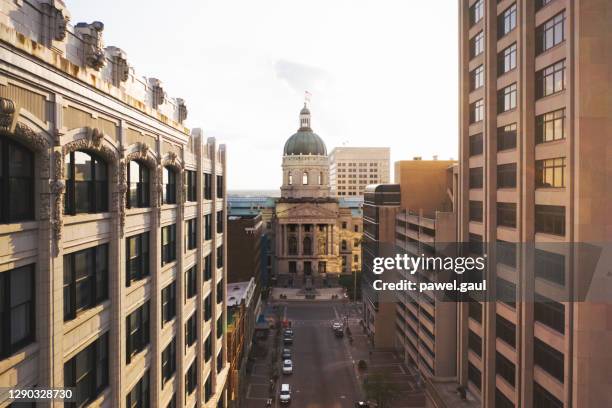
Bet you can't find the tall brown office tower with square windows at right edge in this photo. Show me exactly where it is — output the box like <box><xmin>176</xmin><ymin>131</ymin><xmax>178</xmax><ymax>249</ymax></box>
<box><xmin>428</xmin><ymin>0</ymin><xmax>612</xmax><ymax>408</ymax></box>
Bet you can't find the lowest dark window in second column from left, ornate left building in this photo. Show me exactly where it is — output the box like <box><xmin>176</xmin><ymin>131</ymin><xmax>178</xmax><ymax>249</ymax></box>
<box><xmin>64</xmin><ymin>332</ymin><xmax>109</xmax><ymax>407</ymax></box>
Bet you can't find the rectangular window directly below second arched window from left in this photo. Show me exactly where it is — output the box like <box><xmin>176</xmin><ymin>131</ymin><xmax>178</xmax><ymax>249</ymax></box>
<box><xmin>64</xmin><ymin>244</ymin><xmax>108</xmax><ymax>321</ymax></box>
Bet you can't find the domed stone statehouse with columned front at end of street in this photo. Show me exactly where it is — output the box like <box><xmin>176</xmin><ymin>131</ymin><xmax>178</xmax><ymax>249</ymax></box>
<box><xmin>271</xmin><ymin>104</ymin><xmax>362</xmax><ymax>285</ymax></box>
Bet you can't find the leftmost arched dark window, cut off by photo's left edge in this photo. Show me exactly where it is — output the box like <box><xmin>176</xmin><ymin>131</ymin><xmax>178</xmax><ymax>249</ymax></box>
<box><xmin>0</xmin><ymin>136</ymin><xmax>34</xmax><ymax>224</ymax></box>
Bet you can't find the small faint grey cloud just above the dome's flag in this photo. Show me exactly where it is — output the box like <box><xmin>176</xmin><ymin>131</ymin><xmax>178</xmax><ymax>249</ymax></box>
<box><xmin>274</xmin><ymin>59</ymin><xmax>333</xmax><ymax>94</ymax></box>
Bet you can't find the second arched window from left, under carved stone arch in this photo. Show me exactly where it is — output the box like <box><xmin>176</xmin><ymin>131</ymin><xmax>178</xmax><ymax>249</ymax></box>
<box><xmin>64</xmin><ymin>151</ymin><xmax>108</xmax><ymax>215</ymax></box>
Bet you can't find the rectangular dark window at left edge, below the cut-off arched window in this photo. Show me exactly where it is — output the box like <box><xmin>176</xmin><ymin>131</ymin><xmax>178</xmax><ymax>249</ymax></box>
<box><xmin>0</xmin><ymin>264</ymin><xmax>35</xmax><ymax>358</ymax></box>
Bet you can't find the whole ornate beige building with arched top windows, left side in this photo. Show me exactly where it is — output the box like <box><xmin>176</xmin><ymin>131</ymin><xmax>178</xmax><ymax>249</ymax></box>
<box><xmin>0</xmin><ymin>0</ymin><xmax>228</xmax><ymax>407</ymax></box>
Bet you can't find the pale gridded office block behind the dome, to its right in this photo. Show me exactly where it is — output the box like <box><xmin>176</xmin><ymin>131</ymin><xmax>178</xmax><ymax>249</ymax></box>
<box><xmin>329</xmin><ymin>147</ymin><xmax>390</xmax><ymax>197</ymax></box>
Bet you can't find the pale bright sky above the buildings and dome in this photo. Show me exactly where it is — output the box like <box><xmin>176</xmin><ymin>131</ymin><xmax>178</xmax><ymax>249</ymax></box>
<box><xmin>66</xmin><ymin>0</ymin><xmax>458</xmax><ymax>190</ymax></box>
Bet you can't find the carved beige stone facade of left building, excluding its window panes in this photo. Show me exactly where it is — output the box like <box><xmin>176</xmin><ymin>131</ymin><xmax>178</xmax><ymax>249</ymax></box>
<box><xmin>0</xmin><ymin>0</ymin><xmax>228</xmax><ymax>407</ymax></box>
